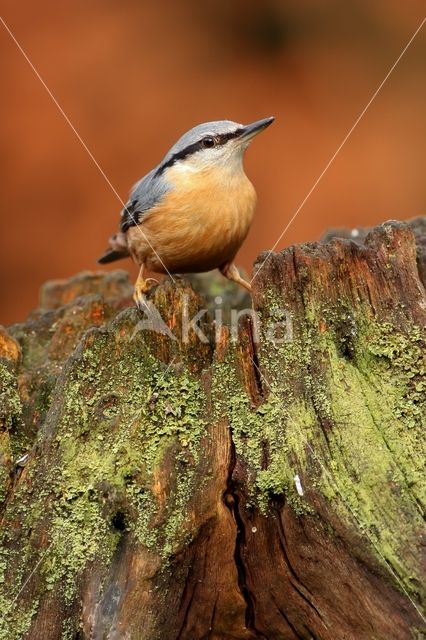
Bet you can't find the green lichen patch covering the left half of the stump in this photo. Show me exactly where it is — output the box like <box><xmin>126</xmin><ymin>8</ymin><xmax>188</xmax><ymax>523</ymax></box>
<box><xmin>0</xmin><ymin>314</ymin><xmax>206</xmax><ymax>640</ymax></box>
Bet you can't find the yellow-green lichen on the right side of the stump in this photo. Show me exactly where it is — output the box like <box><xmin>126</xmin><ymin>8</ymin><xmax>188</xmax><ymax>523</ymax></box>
<box><xmin>260</xmin><ymin>290</ymin><xmax>426</xmax><ymax>595</ymax></box>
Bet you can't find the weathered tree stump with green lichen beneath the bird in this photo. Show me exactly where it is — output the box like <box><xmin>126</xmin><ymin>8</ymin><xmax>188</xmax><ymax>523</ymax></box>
<box><xmin>0</xmin><ymin>219</ymin><xmax>426</xmax><ymax>640</ymax></box>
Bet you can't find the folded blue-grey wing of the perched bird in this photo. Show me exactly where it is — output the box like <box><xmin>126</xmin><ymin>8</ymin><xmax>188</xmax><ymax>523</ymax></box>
<box><xmin>120</xmin><ymin>168</ymin><xmax>171</xmax><ymax>232</ymax></box>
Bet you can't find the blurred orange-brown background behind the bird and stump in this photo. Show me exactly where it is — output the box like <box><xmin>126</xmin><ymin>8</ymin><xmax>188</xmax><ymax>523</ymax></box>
<box><xmin>0</xmin><ymin>0</ymin><xmax>426</xmax><ymax>324</ymax></box>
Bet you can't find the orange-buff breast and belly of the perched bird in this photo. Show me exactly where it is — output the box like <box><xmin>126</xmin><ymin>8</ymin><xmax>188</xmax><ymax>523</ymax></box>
<box><xmin>128</xmin><ymin>168</ymin><xmax>256</xmax><ymax>273</ymax></box>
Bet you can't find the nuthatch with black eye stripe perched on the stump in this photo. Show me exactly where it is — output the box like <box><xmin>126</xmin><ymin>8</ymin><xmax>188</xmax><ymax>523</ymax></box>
<box><xmin>98</xmin><ymin>117</ymin><xmax>275</xmax><ymax>308</ymax></box>
